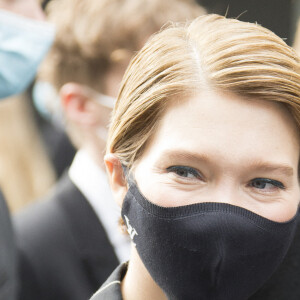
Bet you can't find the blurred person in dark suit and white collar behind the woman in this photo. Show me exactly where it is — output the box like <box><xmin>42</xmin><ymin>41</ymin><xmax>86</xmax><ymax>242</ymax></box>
<box><xmin>14</xmin><ymin>0</ymin><xmax>205</xmax><ymax>300</ymax></box>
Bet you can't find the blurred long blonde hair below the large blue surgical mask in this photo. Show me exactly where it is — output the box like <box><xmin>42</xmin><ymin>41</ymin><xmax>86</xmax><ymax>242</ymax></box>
<box><xmin>0</xmin><ymin>93</ymin><xmax>56</xmax><ymax>213</ymax></box>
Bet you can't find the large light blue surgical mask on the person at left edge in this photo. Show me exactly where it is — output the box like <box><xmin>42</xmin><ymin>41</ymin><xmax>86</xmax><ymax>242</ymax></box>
<box><xmin>0</xmin><ymin>10</ymin><xmax>55</xmax><ymax>99</ymax></box>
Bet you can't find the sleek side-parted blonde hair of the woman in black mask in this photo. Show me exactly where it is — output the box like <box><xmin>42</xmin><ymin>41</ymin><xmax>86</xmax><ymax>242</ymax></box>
<box><xmin>107</xmin><ymin>15</ymin><xmax>300</xmax><ymax>168</ymax></box>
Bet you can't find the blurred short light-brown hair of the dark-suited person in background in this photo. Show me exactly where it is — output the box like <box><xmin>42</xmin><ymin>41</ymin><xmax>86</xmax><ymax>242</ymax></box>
<box><xmin>39</xmin><ymin>0</ymin><xmax>205</xmax><ymax>92</ymax></box>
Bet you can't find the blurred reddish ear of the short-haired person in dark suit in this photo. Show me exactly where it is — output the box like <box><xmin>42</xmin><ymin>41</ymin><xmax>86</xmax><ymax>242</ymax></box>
<box><xmin>60</xmin><ymin>83</ymin><xmax>99</xmax><ymax>127</ymax></box>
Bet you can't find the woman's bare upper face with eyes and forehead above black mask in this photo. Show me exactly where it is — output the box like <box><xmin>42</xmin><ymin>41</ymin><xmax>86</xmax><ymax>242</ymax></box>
<box><xmin>134</xmin><ymin>92</ymin><xmax>300</xmax><ymax>222</ymax></box>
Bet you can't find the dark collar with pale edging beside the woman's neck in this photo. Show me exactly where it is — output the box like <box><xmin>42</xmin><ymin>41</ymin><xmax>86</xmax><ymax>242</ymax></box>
<box><xmin>90</xmin><ymin>263</ymin><xmax>127</xmax><ymax>300</ymax></box>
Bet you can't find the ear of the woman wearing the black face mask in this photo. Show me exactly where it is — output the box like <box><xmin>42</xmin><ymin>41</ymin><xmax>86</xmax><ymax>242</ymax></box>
<box><xmin>104</xmin><ymin>153</ymin><xmax>128</xmax><ymax>207</ymax></box>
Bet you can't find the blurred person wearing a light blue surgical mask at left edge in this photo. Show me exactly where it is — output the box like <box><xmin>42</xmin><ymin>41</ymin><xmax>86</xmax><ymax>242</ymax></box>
<box><xmin>0</xmin><ymin>0</ymin><xmax>54</xmax><ymax>300</ymax></box>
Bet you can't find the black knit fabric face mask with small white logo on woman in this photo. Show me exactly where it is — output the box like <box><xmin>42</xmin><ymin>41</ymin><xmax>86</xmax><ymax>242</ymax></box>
<box><xmin>122</xmin><ymin>183</ymin><xmax>296</xmax><ymax>300</ymax></box>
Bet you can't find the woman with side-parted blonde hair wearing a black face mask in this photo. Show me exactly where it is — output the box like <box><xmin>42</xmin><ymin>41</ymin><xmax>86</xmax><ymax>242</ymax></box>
<box><xmin>92</xmin><ymin>15</ymin><xmax>300</xmax><ymax>300</ymax></box>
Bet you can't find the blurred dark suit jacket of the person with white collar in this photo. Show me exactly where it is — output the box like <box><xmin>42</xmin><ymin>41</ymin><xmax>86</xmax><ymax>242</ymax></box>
<box><xmin>14</xmin><ymin>176</ymin><xmax>118</xmax><ymax>300</ymax></box>
